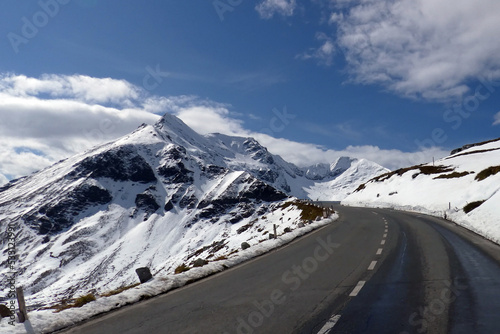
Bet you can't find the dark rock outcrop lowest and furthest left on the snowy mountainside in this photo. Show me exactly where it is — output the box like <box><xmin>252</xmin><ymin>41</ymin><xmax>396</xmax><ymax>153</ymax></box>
<box><xmin>23</xmin><ymin>184</ymin><xmax>113</xmax><ymax>234</ymax></box>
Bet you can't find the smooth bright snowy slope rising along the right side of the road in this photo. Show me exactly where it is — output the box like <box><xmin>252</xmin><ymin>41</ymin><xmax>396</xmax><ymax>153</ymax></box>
<box><xmin>342</xmin><ymin>139</ymin><xmax>500</xmax><ymax>243</ymax></box>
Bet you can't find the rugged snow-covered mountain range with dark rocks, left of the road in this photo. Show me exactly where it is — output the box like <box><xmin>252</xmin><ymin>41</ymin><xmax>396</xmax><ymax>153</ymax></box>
<box><xmin>0</xmin><ymin>114</ymin><xmax>381</xmax><ymax>306</ymax></box>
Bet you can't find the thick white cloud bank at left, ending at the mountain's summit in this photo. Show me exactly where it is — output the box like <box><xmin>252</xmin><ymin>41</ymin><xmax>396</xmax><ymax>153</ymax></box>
<box><xmin>0</xmin><ymin>74</ymin><xmax>159</xmax><ymax>179</ymax></box>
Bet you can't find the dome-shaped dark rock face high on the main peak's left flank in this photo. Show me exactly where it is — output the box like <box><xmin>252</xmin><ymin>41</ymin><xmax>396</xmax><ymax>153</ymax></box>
<box><xmin>70</xmin><ymin>146</ymin><xmax>156</xmax><ymax>183</ymax></box>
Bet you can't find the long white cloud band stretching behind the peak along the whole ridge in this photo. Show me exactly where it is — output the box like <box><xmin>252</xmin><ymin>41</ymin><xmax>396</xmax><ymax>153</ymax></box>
<box><xmin>0</xmin><ymin>75</ymin><xmax>450</xmax><ymax>184</ymax></box>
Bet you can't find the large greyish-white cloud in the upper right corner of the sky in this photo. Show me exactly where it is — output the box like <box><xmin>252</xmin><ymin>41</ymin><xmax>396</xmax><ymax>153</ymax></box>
<box><xmin>332</xmin><ymin>0</ymin><xmax>500</xmax><ymax>101</ymax></box>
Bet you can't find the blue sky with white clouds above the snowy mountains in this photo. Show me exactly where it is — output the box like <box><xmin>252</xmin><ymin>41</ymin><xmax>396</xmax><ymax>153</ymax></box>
<box><xmin>0</xmin><ymin>0</ymin><xmax>500</xmax><ymax>183</ymax></box>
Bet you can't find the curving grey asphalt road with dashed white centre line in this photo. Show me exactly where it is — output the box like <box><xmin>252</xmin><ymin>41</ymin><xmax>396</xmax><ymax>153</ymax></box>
<box><xmin>58</xmin><ymin>203</ymin><xmax>500</xmax><ymax>334</ymax></box>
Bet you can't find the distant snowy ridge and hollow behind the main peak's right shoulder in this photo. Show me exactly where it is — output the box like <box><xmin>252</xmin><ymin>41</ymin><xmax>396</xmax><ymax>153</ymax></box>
<box><xmin>208</xmin><ymin>134</ymin><xmax>389</xmax><ymax>201</ymax></box>
